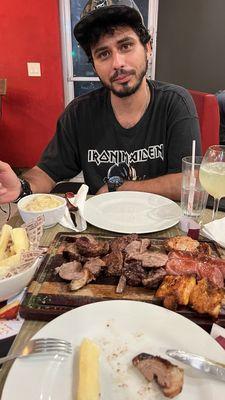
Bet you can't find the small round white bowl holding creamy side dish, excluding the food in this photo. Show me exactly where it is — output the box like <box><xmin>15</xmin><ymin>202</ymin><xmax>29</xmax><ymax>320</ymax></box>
<box><xmin>18</xmin><ymin>193</ymin><xmax>66</xmax><ymax>228</ymax></box>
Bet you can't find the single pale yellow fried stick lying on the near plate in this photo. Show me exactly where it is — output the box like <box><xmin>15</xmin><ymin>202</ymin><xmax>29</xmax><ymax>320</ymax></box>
<box><xmin>76</xmin><ymin>339</ymin><xmax>100</xmax><ymax>400</ymax></box>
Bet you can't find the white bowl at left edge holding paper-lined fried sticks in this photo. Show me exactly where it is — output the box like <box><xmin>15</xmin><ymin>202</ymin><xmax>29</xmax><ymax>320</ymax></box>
<box><xmin>0</xmin><ymin>257</ymin><xmax>42</xmax><ymax>301</ymax></box>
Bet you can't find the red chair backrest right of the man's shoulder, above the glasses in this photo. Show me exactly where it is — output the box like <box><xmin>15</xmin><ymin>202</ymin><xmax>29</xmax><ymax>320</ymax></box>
<box><xmin>189</xmin><ymin>90</ymin><xmax>220</xmax><ymax>155</ymax></box>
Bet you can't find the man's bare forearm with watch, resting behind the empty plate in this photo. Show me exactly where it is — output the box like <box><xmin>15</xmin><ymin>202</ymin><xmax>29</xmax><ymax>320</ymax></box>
<box><xmin>97</xmin><ymin>173</ymin><xmax>182</xmax><ymax>201</ymax></box>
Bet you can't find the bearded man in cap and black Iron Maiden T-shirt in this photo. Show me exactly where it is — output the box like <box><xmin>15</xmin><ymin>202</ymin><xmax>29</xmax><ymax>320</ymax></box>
<box><xmin>0</xmin><ymin>0</ymin><xmax>200</xmax><ymax>203</ymax></box>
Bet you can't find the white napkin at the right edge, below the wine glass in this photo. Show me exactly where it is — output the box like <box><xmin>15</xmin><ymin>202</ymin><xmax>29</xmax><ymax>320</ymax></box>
<box><xmin>201</xmin><ymin>217</ymin><xmax>225</xmax><ymax>248</ymax></box>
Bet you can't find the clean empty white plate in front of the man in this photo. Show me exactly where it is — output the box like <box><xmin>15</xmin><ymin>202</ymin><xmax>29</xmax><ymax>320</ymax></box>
<box><xmin>84</xmin><ymin>192</ymin><xmax>181</xmax><ymax>233</ymax></box>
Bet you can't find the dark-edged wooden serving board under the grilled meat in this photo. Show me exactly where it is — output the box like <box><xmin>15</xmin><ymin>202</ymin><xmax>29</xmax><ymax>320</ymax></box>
<box><xmin>20</xmin><ymin>232</ymin><xmax>225</xmax><ymax>331</ymax></box>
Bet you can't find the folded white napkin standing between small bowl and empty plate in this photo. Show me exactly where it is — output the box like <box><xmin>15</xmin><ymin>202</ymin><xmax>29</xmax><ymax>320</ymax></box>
<box><xmin>59</xmin><ymin>184</ymin><xmax>89</xmax><ymax>232</ymax></box>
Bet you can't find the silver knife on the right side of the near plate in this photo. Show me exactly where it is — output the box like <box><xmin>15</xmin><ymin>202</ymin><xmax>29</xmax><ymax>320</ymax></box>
<box><xmin>166</xmin><ymin>350</ymin><xmax>225</xmax><ymax>382</ymax></box>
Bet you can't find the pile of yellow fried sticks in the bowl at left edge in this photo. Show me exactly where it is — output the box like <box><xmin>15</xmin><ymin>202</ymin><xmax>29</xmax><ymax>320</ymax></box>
<box><xmin>0</xmin><ymin>224</ymin><xmax>30</xmax><ymax>279</ymax></box>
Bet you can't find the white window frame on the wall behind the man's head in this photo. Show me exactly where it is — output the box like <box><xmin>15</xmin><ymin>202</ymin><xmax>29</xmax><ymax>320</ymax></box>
<box><xmin>59</xmin><ymin>0</ymin><xmax>159</xmax><ymax>106</ymax></box>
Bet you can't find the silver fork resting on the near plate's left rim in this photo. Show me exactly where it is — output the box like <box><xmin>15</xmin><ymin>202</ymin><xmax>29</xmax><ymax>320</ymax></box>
<box><xmin>0</xmin><ymin>338</ymin><xmax>72</xmax><ymax>364</ymax></box>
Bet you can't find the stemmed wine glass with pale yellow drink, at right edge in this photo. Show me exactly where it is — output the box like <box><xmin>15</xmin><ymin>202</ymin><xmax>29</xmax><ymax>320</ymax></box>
<box><xmin>199</xmin><ymin>145</ymin><xmax>225</xmax><ymax>221</ymax></box>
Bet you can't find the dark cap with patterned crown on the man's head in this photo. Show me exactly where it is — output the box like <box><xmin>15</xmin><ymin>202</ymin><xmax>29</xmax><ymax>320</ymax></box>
<box><xmin>73</xmin><ymin>0</ymin><xmax>144</xmax><ymax>45</ymax></box>
